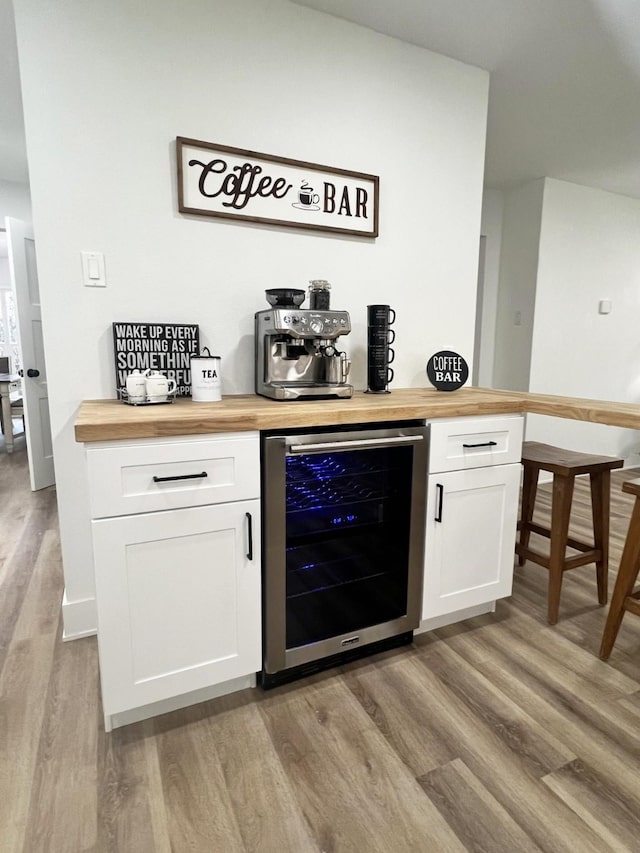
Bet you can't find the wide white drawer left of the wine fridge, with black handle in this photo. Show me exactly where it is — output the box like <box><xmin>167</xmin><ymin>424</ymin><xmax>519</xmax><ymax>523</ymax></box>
<box><xmin>87</xmin><ymin>432</ymin><xmax>260</xmax><ymax>518</ymax></box>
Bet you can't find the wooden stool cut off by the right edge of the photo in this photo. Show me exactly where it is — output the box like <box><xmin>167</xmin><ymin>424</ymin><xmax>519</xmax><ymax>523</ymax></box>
<box><xmin>600</xmin><ymin>480</ymin><xmax>640</xmax><ymax>660</ymax></box>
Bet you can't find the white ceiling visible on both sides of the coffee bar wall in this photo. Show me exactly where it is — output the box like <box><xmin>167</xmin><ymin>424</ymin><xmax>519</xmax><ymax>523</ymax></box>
<box><xmin>0</xmin><ymin>0</ymin><xmax>640</xmax><ymax>198</ymax></box>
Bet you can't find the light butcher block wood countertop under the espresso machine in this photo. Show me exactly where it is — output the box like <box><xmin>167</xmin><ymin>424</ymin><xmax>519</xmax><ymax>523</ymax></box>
<box><xmin>75</xmin><ymin>387</ymin><xmax>640</xmax><ymax>442</ymax></box>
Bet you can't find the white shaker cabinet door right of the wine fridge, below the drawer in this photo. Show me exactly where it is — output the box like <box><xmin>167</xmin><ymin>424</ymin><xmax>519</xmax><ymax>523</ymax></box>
<box><xmin>422</xmin><ymin>463</ymin><xmax>521</xmax><ymax>619</ymax></box>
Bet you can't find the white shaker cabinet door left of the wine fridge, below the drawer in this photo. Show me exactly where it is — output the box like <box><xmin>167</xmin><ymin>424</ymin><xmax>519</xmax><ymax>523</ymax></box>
<box><xmin>92</xmin><ymin>500</ymin><xmax>261</xmax><ymax>714</ymax></box>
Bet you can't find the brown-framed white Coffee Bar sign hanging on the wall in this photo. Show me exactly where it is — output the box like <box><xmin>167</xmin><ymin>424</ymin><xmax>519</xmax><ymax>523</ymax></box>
<box><xmin>176</xmin><ymin>136</ymin><xmax>379</xmax><ymax>237</ymax></box>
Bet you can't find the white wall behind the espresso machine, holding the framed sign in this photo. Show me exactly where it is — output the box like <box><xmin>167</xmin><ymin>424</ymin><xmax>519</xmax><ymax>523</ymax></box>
<box><xmin>15</xmin><ymin>0</ymin><xmax>488</xmax><ymax>633</ymax></box>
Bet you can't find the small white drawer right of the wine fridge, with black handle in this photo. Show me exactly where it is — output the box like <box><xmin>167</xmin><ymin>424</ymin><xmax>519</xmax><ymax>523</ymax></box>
<box><xmin>429</xmin><ymin>415</ymin><xmax>524</xmax><ymax>473</ymax></box>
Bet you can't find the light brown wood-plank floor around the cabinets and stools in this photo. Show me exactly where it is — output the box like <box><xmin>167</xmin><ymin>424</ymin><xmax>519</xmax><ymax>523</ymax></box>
<box><xmin>0</xmin><ymin>452</ymin><xmax>640</xmax><ymax>853</ymax></box>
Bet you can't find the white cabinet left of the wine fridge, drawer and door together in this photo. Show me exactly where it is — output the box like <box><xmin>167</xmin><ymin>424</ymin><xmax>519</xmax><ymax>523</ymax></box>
<box><xmin>87</xmin><ymin>433</ymin><xmax>261</xmax><ymax>729</ymax></box>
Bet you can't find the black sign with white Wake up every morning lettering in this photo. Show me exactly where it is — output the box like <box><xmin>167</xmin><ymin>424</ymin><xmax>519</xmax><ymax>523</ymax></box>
<box><xmin>113</xmin><ymin>323</ymin><xmax>200</xmax><ymax>397</ymax></box>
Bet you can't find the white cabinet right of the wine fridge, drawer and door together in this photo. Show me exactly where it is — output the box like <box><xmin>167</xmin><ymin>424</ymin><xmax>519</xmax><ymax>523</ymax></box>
<box><xmin>422</xmin><ymin>415</ymin><xmax>522</xmax><ymax>621</ymax></box>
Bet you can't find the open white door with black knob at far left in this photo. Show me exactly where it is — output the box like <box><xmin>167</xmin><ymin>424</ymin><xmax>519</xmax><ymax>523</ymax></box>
<box><xmin>5</xmin><ymin>217</ymin><xmax>55</xmax><ymax>491</ymax></box>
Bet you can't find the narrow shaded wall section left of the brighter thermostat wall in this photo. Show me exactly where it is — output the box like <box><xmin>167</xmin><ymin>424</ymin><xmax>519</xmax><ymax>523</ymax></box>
<box><xmin>493</xmin><ymin>179</ymin><xmax>544</xmax><ymax>391</ymax></box>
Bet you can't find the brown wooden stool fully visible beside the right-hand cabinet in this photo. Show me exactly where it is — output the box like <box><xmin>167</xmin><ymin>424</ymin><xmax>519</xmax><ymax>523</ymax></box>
<box><xmin>516</xmin><ymin>441</ymin><xmax>624</xmax><ymax>625</ymax></box>
